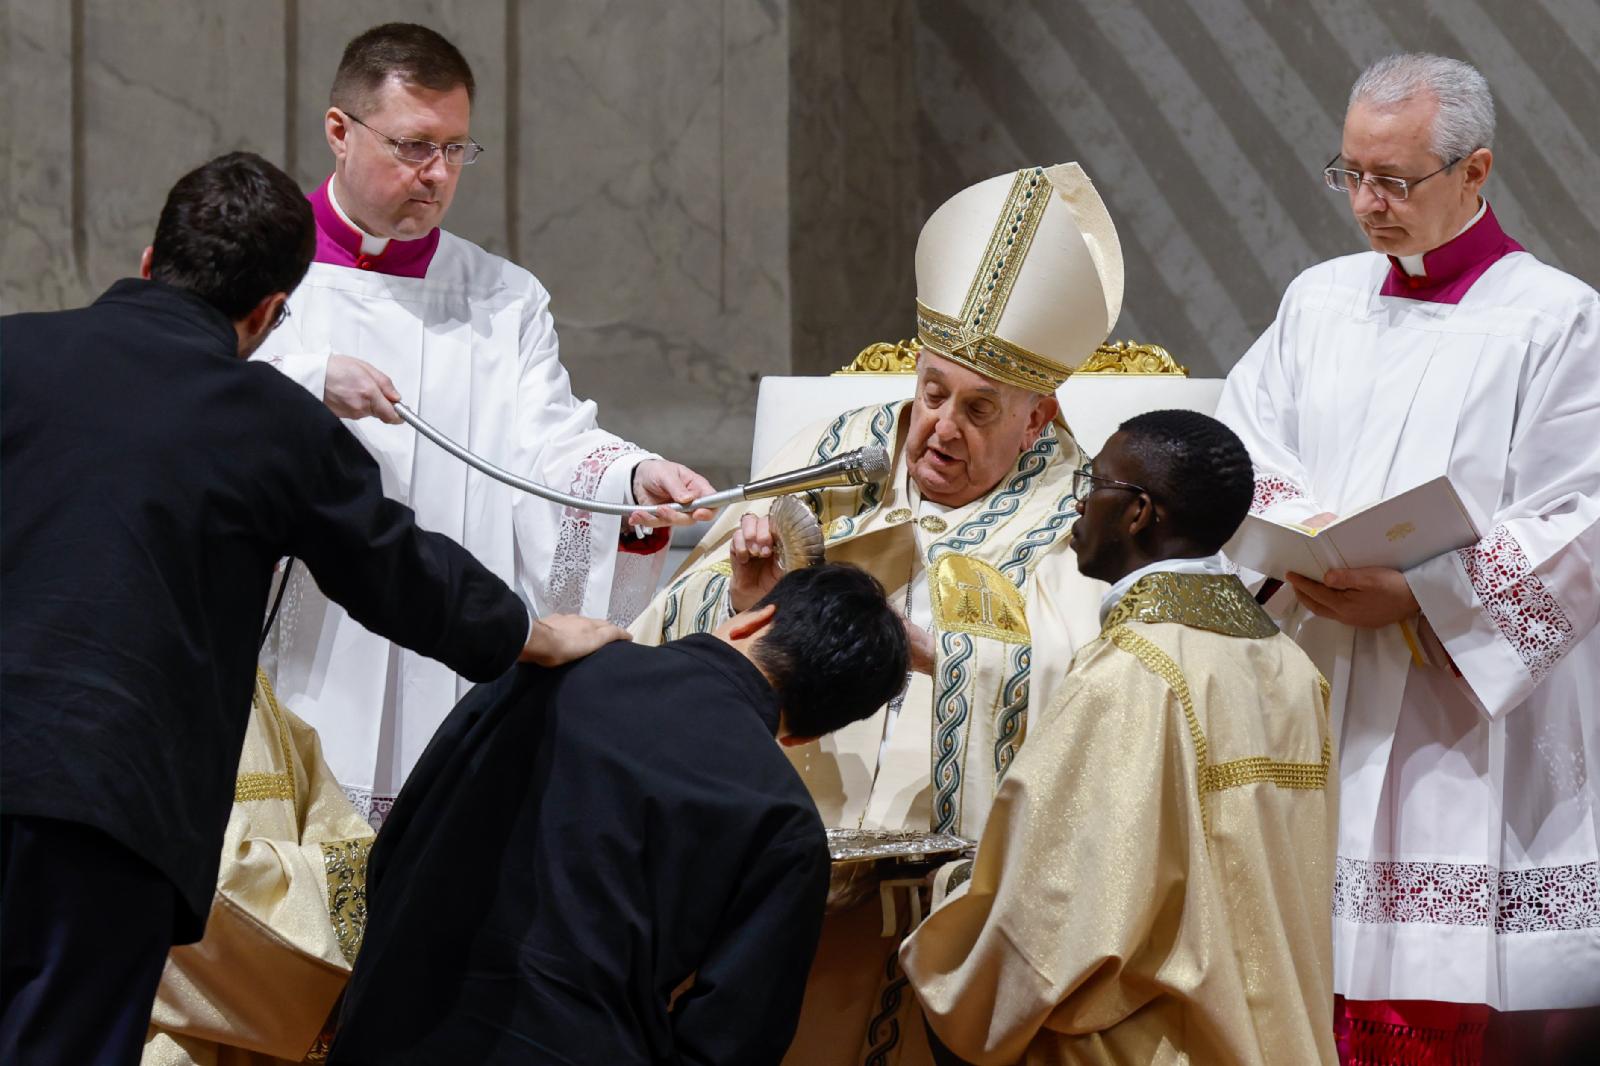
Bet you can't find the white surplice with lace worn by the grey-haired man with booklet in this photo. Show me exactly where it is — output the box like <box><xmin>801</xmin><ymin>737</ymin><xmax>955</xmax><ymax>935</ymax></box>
<box><xmin>1218</xmin><ymin>240</ymin><xmax>1600</xmax><ymax>1010</ymax></box>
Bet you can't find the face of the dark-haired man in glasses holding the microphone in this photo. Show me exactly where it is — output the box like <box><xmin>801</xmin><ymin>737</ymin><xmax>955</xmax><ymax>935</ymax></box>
<box><xmin>325</xmin><ymin>78</ymin><xmax>472</xmax><ymax>240</ymax></box>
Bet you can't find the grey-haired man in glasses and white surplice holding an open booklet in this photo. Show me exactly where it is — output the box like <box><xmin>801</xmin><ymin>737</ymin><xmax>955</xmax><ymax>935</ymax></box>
<box><xmin>1218</xmin><ymin>54</ymin><xmax>1600</xmax><ymax>1063</ymax></box>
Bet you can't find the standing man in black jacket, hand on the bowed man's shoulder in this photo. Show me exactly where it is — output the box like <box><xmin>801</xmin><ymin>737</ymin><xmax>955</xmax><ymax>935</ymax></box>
<box><xmin>0</xmin><ymin>154</ymin><xmax>619</xmax><ymax>1066</ymax></box>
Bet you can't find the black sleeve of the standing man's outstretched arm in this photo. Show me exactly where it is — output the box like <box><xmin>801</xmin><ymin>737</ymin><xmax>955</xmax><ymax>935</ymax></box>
<box><xmin>290</xmin><ymin>411</ymin><xmax>530</xmax><ymax>682</ymax></box>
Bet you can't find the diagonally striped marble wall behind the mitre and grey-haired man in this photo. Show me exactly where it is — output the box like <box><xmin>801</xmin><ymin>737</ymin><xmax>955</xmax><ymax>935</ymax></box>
<box><xmin>912</xmin><ymin>0</ymin><xmax>1600</xmax><ymax>375</ymax></box>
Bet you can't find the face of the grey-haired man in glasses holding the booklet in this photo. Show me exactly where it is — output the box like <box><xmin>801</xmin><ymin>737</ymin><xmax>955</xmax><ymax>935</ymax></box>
<box><xmin>1334</xmin><ymin>94</ymin><xmax>1490</xmax><ymax>256</ymax></box>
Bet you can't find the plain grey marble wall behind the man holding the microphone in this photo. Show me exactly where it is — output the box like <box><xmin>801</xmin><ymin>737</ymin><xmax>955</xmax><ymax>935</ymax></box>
<box><xmin>0</xmin><ymin>0</ymin><xmax>792</xmax><ymax>482</ymax></box>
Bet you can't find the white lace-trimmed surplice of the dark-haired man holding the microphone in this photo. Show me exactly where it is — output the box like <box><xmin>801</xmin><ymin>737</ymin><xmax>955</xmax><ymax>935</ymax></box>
<box><xmin>256</xmin><ymin>232</ymin><xmax>666</xmax><ymax>824</ymax></box>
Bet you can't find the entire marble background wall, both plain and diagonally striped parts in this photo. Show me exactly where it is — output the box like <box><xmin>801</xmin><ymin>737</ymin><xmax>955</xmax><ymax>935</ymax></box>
<box><xmin>0</xmin><ymin>0</ymin><xmax>1600</xmax><ymax>482</ymax></box>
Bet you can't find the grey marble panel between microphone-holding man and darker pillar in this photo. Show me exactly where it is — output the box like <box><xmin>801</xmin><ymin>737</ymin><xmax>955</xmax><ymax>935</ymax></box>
<box><xmin>517</xmin><ymin>0</ymin><xmax>789</xmax><ymax>482</ymax></box>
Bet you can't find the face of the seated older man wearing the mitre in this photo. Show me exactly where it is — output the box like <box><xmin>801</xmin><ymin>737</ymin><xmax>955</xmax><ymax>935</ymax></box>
<box><xmin>906</xmin><ymin>349</ymin><xmax>1056</xmax><ymax>507</ymax></box>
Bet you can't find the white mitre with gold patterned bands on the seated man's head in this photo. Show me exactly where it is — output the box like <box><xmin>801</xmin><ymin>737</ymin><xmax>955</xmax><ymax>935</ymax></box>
<box><xmin>917</xmin><ymin>163</ymin><xmax>1122</xmax><ymax>395</ymax></box>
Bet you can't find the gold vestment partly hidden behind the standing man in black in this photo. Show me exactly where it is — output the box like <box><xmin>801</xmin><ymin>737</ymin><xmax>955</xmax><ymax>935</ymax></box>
<box><xmin>141</xmin><ymin>671</ymin><xmax>373</xmax><ymax>1066</ymax></box>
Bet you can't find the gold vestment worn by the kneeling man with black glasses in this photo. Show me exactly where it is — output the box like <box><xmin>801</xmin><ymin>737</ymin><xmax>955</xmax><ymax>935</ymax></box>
<box><xmin>901</xmin><ymin>571</ymin><xmax>1338</xmax><ymax>1066</ymax></box>
